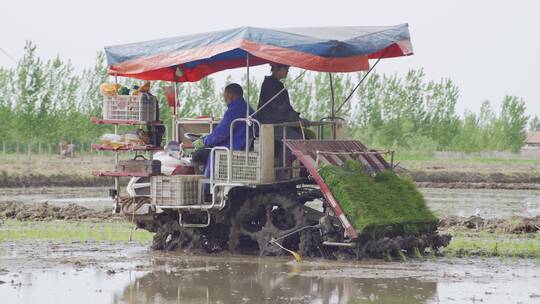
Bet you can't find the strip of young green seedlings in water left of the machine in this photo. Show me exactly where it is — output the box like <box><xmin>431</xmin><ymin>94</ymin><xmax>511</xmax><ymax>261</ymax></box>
<box><xmin>0</xmin><ymin>220</ymin><xmax>152</xmax><ymax>243</ymax></box>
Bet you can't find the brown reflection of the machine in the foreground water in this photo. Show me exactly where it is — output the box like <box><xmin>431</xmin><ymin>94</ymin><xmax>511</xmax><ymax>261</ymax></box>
<box><xmin>114</xmin><ymin>258</ymin><xmax>437</xmax><ymax>304</ymax></box>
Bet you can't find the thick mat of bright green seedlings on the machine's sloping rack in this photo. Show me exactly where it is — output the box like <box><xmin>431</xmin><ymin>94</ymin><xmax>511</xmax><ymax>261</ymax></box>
<box><xmin>320</xmin><ymin>161</ymin><xmax>437</xmax><ymax>237</ymax></box>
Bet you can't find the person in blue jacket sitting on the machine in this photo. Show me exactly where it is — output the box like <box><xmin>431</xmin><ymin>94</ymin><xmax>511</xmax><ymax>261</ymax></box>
<box><xmin>193</xmin><ymin>83</ymin><xmax>253</xmax><ymax>177</ymax></box>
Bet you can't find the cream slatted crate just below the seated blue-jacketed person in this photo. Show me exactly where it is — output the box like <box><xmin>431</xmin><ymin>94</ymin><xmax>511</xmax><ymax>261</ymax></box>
<box><xmin>214</xmin><ymin>150</ymin><xmax>261</xmax><ymax>183</ymax></box>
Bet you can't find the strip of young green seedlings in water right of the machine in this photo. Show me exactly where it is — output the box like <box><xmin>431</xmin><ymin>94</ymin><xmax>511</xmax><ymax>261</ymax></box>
<box><xmin>441</xmin><ymin>232</ymin><xmax>540</xmax><ymax>259</ymax></box>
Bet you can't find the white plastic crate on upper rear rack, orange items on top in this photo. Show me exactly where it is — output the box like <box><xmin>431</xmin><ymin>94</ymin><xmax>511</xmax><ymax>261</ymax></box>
<box><xmin>103</xmin><ymin>94</ymin><xmax>156</xmax><ymax>121</ymax></box>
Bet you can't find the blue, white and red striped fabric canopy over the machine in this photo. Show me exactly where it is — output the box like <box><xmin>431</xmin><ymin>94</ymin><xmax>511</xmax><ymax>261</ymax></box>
<box><xmin>105</xmin><ymin>24</ymin><xmax>413</xmax><ymax>82</ymax></box>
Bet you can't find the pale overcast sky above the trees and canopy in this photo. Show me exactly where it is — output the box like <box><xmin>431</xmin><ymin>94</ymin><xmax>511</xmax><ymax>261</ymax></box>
<box><xmin>0</xmin><ymin>0</ymin><xmax>540</xmax><ymax>115</ymax></box>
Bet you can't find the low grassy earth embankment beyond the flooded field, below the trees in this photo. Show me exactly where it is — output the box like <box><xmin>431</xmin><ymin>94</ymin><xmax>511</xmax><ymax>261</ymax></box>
<box><xmin>0</xmin><ymin>155</ymin><xmax>540</xmax><ymax>189</ymax></box>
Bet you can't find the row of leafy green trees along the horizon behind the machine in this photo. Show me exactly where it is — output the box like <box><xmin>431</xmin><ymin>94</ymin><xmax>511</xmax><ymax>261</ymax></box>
<box><xmin>0</xmin><ymin>42</ymin><xmax>540</xmax><ymax>152</ymax></box>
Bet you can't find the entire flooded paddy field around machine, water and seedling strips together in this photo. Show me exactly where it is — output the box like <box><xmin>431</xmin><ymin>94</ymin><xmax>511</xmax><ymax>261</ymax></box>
<box><xmin>0</xmin><ymin>188</ymin><xmax>540</xmax><ymax>304</ymax></box>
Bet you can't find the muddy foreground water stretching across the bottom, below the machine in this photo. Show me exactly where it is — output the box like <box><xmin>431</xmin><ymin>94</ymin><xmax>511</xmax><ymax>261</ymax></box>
<box><xmin>0</xmin><ymin>243</ymin><xmax>540</xmax><ymax>304</ymax></box>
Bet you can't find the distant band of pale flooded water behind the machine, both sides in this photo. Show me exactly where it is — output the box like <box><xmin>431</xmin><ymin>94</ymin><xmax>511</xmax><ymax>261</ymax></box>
<box><xmin>0</xmin><ymin>188</ymin><xmax>540</xmax><ymax>218</ymax></box>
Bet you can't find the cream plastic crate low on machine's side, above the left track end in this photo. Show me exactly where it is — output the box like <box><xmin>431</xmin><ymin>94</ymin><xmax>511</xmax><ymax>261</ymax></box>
<box><xmin>150</xmin><ymin>175</ymin><xmax>204</xmax><ymax>206</ymax></box>
